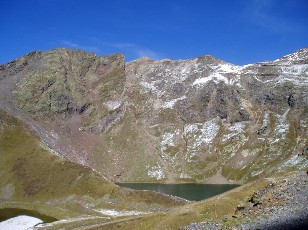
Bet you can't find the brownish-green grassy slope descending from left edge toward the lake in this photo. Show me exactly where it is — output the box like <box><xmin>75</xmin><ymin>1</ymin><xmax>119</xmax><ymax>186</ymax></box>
<box><xmin>0</xmin><ymin>110</ymin><xmax>183</xmax><ymax>219</ymax></box>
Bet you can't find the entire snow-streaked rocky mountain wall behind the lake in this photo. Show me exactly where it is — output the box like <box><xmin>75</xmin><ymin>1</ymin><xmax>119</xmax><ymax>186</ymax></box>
<box><xmin>0</xmin><ymin>49</ymin><xmax>308</xmax><ymax>183</ymax></box>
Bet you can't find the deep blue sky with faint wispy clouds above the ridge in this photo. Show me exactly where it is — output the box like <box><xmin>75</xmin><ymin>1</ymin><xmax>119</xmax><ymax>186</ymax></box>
<box><xmin>0</xmin><ymin>0</ymin><xmax>308</xmax><ymax>65</ymax></box>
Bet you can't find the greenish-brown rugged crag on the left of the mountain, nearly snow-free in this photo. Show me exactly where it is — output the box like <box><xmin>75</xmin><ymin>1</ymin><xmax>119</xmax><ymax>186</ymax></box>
<box><xmin>11</xmin><ymin>49</ymin><xmax>125</xmax><ymax>132</ymax></box>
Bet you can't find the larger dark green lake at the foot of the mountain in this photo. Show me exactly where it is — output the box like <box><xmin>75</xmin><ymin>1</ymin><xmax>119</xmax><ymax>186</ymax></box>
<box><xmin>117</xmin><ymin>183</ymin><xmax>239</xmax><ymax>201</ymax></box>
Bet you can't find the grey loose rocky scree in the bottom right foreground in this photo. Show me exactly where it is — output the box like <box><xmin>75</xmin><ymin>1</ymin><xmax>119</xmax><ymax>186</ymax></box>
<box><xmin>183</xmin><ymin>172</ymin><xmax>308</xmax><ymax>230</ymax></box>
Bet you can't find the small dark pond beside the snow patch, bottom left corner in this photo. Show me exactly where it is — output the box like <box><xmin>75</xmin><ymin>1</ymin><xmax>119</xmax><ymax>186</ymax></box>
<box><xmin>0</xmin><ymin>208</ymin><xmax>57</xmax><ymax>223</ymax></box>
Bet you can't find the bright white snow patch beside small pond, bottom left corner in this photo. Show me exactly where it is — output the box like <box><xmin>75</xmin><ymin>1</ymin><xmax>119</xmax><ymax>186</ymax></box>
<box><xmin>0</xmin><ymin>215</ymin><xmax>43</xmax><ymax>230</ymax></box>
